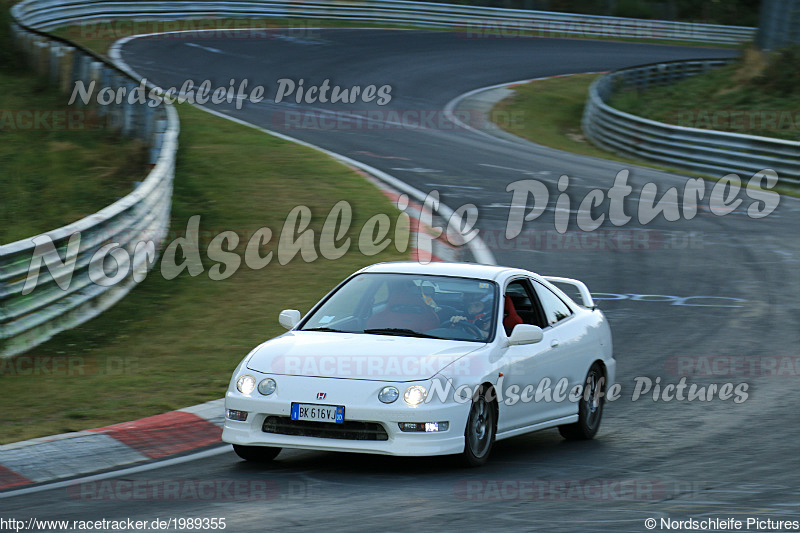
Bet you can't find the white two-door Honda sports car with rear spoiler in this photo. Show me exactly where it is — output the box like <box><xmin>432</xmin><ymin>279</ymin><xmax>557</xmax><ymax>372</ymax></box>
<box><xmin>222</xmin><ymin>262</ymin><xmax>616</xmax><ymax>466</ymax></box>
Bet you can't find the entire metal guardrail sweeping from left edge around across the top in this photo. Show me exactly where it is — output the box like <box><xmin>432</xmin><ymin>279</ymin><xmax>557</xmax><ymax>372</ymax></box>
<box><xmin>0</xmin><ymin>0</ymin><xmax>755</xmax><ymax>356</ymax></box>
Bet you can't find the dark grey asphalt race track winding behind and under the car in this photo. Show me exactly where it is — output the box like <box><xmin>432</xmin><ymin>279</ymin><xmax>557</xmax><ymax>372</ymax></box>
<box><xmin>2</xmin><ymin>30</ymin><xmax>800</xmax><ymax>532</ymax></box>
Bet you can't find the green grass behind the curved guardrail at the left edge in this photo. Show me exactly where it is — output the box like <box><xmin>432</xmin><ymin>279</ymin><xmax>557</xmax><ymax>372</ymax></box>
<box><xmin>0</xmin><ymin>62</ymin><xmax>147</xmax><ymax>244</ymax></box>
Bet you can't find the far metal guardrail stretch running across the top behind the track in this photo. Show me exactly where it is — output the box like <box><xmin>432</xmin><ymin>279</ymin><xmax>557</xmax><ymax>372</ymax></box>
<box><xmin>14</xmin><ymin>0</ymin><xmax>756</xmax><ymax>44</ymax></box>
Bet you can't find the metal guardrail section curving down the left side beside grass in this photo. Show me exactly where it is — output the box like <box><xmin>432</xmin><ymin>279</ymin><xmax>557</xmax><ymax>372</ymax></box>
<box><xmin>0</xmin><ymin>0</ymin><xmax>179</xmax><ymax>356</ymax></box>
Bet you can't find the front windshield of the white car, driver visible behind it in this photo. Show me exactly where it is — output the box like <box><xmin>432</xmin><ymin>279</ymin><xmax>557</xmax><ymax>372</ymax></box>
<box><xmin>300</xmin><ymin>273</ymin><xmax>498</xmax><ymax>342</ymax></box>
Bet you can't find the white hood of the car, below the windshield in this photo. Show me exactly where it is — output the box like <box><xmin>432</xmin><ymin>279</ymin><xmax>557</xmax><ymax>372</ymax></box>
<box><xmin>247</xmin><ymin>331</ymin><xmax>485</xmax><ymax>381</ymax></box>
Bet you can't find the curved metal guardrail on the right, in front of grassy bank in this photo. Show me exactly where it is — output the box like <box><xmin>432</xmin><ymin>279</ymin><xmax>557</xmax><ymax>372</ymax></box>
<box><xmin>582</xmin><ymin>59</ymin><xmax>800</xmax><ymax>184</ymax></box>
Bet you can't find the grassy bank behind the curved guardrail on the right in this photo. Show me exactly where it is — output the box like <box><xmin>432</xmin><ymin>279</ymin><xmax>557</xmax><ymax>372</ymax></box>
<box><xmin>609</xmin><ymin>47</ymin><xmax>800</xmax><ymax>141</ymax></box>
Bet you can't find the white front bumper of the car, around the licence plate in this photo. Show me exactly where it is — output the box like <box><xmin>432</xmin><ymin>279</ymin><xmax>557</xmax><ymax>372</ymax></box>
<box><xmin>222</xmin><ymin>372</ymin><xmax>470</xmax><ymax>456</ymax></box>
